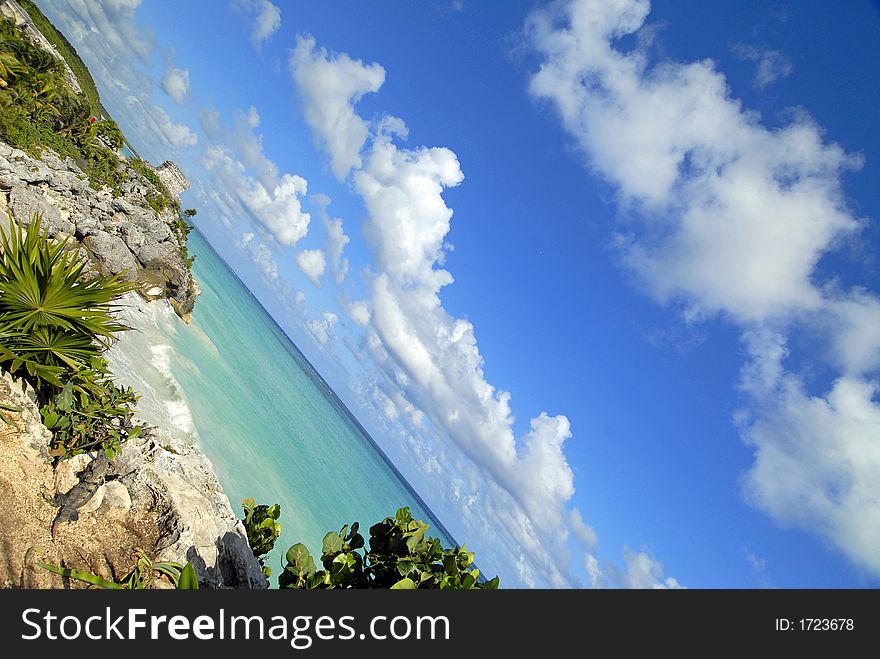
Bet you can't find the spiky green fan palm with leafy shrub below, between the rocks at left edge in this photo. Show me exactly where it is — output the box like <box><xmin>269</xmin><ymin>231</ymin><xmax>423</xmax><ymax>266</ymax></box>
<box><xmin>0</xmin><ymin>216</ymin><xmax>140</xmax><ymax>459</ymax></box>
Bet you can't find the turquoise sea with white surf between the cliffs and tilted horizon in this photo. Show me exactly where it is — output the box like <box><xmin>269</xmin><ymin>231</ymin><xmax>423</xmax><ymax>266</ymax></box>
<box><xmin>110</xmin><ymin>231</ymin><xmax>455</xmax><ymax>585</ymax></box>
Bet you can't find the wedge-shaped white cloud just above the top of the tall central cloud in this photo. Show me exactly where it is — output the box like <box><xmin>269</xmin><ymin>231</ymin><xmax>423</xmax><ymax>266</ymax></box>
<box><xmin>290</xmin><ymin>36</ymin><xmax>385</xmax><ymax>180</ymax></box>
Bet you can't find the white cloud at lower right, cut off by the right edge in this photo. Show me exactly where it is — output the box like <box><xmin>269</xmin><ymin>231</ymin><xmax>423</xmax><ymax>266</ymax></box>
<box><xmin>740</xmin><ymin>336</ymin><xmax>880</xmax><ymax>575</ymax></box>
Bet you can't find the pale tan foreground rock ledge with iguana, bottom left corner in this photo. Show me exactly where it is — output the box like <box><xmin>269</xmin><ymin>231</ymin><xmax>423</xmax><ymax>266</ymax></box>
<box><xmin>0</xmin><ymin>373</ymin><xmax>267</xmax><ymax>588</ymax></box>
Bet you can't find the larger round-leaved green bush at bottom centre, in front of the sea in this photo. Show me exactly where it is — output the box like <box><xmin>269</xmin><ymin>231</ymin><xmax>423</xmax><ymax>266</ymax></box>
<box><xmin>278</xmin><ymin>508</ymin><xmax>498</xmax><ymax>590</ymax></box>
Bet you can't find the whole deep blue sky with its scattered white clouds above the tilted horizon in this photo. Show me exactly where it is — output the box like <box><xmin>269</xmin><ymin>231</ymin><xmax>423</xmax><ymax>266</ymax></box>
<box><xmin>39</xmin><ymin>0</ymin><xmax>880</xmax><ymax>588</ymax></box>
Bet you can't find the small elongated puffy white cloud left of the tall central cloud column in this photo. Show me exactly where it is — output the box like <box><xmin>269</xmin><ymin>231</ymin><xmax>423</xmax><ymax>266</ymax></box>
<box><xmin>203</xmin><ymin>146</ymin><xmax>311</xmax><ymax>247</ymax></box>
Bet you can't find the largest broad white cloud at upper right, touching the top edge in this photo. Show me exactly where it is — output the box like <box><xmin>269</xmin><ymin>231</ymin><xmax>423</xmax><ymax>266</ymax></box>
<box><xmin>529</xmin><ymin>0</ymin><xmax>859</xmax><ymax>321</ymax></box>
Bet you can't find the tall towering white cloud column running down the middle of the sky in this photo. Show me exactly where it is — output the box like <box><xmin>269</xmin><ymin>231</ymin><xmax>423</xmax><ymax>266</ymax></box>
<box><xmin>354</xmin><ymin>118</ymin><xmax>574</xmax><ymax>585</ymax></box>
